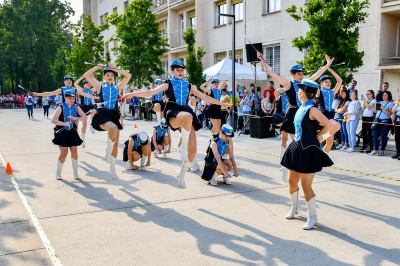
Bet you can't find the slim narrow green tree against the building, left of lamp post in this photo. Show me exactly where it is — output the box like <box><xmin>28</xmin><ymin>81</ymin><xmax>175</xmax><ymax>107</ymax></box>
<box><xmin>183</xmin><ymin>27</ymin><xmax>205</xmax><ymax>88</ymax></box>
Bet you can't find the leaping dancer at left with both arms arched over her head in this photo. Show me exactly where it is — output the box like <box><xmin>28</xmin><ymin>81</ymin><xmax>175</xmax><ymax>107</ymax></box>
<box><xmin>83</xmin><ymin>62</ymin><xmax>131</xmax><ymax>179</ymax></box>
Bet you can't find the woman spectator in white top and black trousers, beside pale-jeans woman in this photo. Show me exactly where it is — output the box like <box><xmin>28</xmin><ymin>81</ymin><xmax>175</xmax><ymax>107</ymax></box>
<box><xmin>360</xmin><ymin>90</ymin><xmax>376</xmax><ymax>153</ymax></box>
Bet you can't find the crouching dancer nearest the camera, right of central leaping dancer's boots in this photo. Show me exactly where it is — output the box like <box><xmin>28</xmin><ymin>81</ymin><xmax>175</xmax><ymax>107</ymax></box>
<box><xmin>201</xmin><ymin>124</ymin><xmax>239</xmax><ymax>186</ymax></box>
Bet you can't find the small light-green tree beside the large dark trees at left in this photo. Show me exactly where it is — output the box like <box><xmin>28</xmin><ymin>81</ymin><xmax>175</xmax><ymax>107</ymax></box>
<box><xmin>66</xmin><ymin>13</ymin><xmax>108</xmax><ymax>77</ymax></box>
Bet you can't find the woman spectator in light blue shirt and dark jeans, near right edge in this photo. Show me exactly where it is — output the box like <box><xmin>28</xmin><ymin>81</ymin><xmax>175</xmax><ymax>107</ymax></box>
<box><xmin>370</xmin><ymin>92</ymin><xmax>394</xmax><ymax>156</ymax></box>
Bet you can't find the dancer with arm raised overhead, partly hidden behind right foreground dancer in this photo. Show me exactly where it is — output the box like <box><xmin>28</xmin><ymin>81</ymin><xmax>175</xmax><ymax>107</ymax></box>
<box><xmin>315</xmin><ymin>68</ymin><xmax>343</xmax><ymax>153</ymax></box>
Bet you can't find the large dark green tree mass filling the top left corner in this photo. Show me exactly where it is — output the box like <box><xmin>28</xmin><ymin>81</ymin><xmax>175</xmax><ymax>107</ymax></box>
<box><xmin>0</xmin><ymin>0</ymin><xmax>74</xmax><ymax>91</ymax></box>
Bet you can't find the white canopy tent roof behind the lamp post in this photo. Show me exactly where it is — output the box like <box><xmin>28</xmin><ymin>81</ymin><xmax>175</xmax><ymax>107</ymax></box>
<box><xmin>203</xmin><ymin>58</ymin><xmax>267</xmax><ymax>80</ymax></box>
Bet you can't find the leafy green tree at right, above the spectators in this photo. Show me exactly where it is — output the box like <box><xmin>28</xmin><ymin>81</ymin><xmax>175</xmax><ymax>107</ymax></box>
<box><xmin>286</xmin><ymin>0</ymin><xmax>369</xmax><ymax>84</ymax></box>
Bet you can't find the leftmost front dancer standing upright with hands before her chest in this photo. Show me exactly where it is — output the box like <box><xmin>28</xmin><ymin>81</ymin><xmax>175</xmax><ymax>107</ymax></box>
<box><xmin>51</xmin><ymin>89</ymin><xmax>86</xmax><ymax>180</ymax></box>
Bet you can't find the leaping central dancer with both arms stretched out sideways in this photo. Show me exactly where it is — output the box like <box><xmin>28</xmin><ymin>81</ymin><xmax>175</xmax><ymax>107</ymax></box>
<box><xmin>123</xmin><ymin>60</ymin><xmax>230</xmax><ymax>188</ymax></box>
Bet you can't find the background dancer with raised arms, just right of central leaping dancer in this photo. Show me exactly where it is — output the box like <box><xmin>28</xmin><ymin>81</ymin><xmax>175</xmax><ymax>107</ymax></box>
<box><xmin>200</xmin><ymin>78</ymin><xmax>226</xmax><ymax>134</ymax></box>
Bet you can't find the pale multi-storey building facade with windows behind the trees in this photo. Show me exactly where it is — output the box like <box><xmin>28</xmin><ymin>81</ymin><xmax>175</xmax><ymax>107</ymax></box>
<box><xmin>83</xmin><ymin>0</ymin><xmax>400</xmax><ymax>97</ymax></box>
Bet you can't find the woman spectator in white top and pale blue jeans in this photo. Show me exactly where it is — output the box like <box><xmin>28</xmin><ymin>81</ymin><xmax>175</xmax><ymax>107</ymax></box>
<box><xmin>344</xmin><ymin>90</ymin><xmax>361</xmax><ymax>152</ymax></box>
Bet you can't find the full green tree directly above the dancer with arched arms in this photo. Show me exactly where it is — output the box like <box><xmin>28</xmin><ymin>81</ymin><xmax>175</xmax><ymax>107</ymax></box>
<box><xmin>108</xmin><ymin>0</ymin><xmax>168</xmax><ymax>88</ymax></box>
